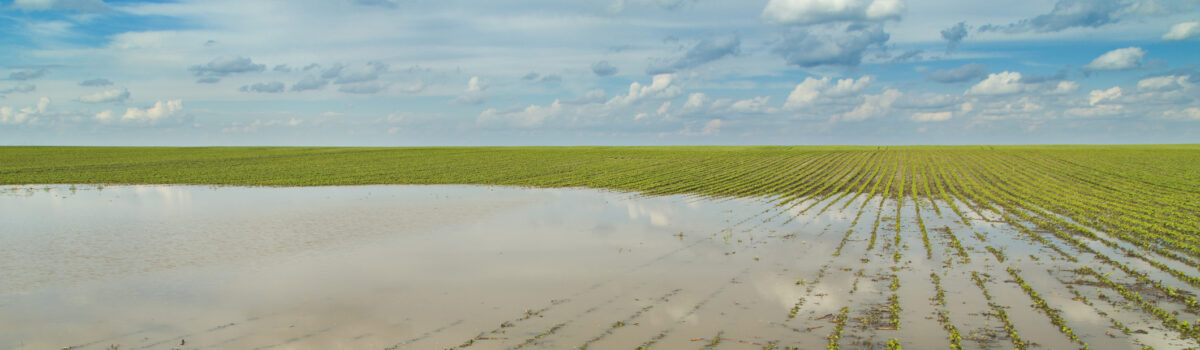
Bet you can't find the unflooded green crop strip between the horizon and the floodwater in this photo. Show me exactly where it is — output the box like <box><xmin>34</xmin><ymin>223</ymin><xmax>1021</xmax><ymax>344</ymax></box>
<box><xmin>7</xmin><ymin>145</ymin><xmax>1200</xmax><ymax>250</ymax></box>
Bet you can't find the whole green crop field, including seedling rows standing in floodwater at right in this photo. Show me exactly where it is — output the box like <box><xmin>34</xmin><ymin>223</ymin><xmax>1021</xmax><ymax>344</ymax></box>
<box><xmin>0</xmin><ymin>145</ymin><xmax>1200</xmax><ymax>349</ymax></box>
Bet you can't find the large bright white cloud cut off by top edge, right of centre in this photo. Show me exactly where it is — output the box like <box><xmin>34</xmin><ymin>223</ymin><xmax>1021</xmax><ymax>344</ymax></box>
<box><xmin>762</xmin><ymin>0</ymin><xmax>905</xmax><ymax>25</ymax></box>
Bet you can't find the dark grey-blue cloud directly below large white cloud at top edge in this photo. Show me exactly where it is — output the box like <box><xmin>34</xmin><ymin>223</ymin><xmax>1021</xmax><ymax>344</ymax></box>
<box><xmin>773</xmin><ymin>23</ymin><xmax>890</xmax><ymax>67</ymax></box>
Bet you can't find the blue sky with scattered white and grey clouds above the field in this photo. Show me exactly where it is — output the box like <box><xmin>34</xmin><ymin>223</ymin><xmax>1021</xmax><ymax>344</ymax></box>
<box><xmin>0</xmin><ymin>0</ymin><xmax>1200</xmax><ymax>146</ymax></box>
